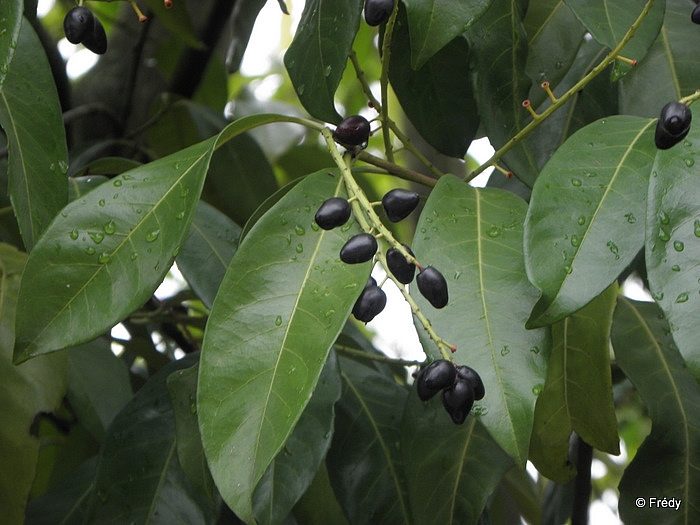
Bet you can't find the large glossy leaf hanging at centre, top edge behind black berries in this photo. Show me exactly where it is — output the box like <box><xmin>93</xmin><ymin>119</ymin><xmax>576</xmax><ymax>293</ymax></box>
<box><xmin>197</xmin><ymin>170</ymin><xmax>370</xmax><ymax>522</ymax></box>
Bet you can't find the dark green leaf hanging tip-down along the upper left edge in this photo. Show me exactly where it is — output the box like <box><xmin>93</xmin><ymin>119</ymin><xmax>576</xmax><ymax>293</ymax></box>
<box><xmin>0</xmin><ymin>17</ymin><xmax>68</xmax><ymax>250</ymax></box>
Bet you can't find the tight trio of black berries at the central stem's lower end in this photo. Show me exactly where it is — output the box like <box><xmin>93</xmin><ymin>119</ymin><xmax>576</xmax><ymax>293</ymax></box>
<box><xmin>416</xmin><ymin>359</ymin><xmax>486</xmax><ymax>425</ymax></box>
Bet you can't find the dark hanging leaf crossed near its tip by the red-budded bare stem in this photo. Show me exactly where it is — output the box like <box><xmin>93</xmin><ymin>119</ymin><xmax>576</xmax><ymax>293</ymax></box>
<box><xmin>466</xmin><ymin>0</ymin><xmax>539</xmax><ymax>187</ymax></box>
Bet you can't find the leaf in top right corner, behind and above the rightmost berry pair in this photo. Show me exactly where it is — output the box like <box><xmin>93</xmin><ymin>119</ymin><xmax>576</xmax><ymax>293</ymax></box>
<box><xmin>620</xmin><ymin>0</ymin><xmax>700</xmax><ymax>117</ymax></box>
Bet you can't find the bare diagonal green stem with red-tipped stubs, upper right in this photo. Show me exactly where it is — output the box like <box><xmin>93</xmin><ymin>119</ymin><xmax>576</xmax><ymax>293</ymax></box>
<box><xmin>464</xmin><ymin>0</ymin><xmax>654</xmax><ymax>182</ymax></box>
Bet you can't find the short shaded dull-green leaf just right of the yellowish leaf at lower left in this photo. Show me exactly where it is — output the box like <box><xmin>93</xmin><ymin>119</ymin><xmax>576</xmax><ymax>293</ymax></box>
<box><xmin>66</xmin><ymin>340</ymin><xmax>132</xmax><ymax>442</ymax></box>
